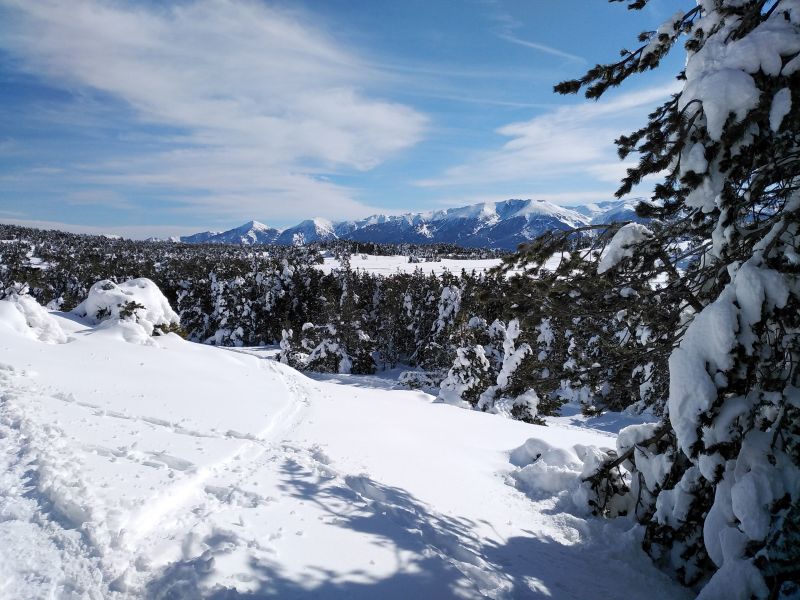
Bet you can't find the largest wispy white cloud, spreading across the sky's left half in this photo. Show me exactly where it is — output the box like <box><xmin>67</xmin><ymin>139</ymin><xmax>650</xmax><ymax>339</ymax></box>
<box><xmin>0</xmin><ymin>0</ymin><xmax>426</xmax><ymax>221</ymax></box>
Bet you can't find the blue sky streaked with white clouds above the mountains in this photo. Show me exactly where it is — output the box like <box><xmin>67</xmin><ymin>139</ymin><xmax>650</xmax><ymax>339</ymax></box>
<box><xmin>0</xmin><ymin>0</ymin><xmax>682</xmax><ymax>237</ymax></box>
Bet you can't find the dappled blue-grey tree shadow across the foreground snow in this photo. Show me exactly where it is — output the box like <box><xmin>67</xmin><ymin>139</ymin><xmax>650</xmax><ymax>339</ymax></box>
<box><xmin>146</xmin><ymin>453</ymin><xmax>678</xmax><ymax>600</ymax></box>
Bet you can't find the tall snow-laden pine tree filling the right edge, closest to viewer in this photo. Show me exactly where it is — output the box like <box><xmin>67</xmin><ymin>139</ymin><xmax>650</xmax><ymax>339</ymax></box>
<box><xmin>556</xmin><ymin>0</ymin><xmax>800</xmax><ymax>598</ymax></box>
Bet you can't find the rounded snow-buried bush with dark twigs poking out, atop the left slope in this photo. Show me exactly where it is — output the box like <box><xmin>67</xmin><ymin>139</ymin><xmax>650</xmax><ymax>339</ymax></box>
<box><xmin>73</xmin><ymin>277</ymin><xmax>180</xmax><ymax>335</ymax></box>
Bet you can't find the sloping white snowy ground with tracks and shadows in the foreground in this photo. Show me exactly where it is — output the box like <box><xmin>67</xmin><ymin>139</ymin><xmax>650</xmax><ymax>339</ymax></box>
<box><xmin>0</xmin><ymin>302</ymin><xmax>688</xmax><ymax>599</ymax></box>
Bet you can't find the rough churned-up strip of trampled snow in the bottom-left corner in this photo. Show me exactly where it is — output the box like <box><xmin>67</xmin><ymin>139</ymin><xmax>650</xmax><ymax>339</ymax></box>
<box><xmin>0</xmin><ymin>365</ymin><xmax>108</xmax><ymax>599</ymax></box>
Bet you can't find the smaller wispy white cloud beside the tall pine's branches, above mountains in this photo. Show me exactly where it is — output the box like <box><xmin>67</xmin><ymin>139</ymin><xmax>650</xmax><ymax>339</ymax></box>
<box><xmin>418</xmin><ymin>85</ymin><xmax>677</xmax><ymax>190</ymax></box>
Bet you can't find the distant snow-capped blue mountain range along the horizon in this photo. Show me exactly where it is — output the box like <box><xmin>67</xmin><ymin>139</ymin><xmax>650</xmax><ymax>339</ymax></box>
<box><xmin>181</xmin><ymin>200</ymin><xmax>638</xmax><ymax>249</ymax></box>
